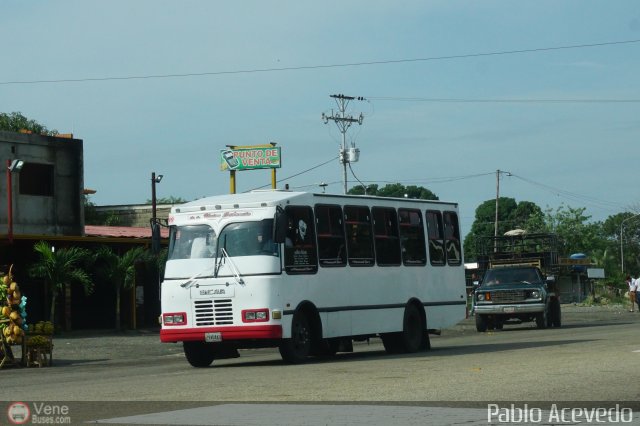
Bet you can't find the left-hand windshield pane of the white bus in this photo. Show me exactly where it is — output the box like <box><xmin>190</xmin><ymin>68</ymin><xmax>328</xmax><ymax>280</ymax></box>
<box><xmin>168</xmin><ymin>225</ymin><xmax>216</xmax><ymax>260</ymax></box>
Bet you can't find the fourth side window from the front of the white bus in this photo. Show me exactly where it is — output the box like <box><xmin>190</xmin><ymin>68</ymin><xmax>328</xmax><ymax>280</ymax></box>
<box><xmin>371</xmin><ymin>207</ymin><xmax>400</xmax><ymax>266</ymax></box>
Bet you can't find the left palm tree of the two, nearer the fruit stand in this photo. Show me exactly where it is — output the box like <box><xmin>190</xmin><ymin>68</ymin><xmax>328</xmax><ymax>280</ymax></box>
<box><xmin>29</xmin><ymin>241</ymin><xmax>93</xmax><ymax>324</ymax></box>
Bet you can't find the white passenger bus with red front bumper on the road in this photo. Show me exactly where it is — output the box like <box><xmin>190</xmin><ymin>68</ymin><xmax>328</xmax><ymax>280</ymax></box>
<box><xmin>160</xmin><ymin>190</ymin><xmax>466</xmax><ymax>367</ymax></box>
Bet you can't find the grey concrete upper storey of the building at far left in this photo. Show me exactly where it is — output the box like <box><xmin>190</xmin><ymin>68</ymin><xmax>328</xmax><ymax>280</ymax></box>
<box><xmin>0</xmin><ymin>131</ymin><xmax>84</xmax><ymax>235</ymax></box>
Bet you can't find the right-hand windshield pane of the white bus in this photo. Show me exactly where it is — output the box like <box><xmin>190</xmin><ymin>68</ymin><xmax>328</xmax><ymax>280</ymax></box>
<box><xmin>219</xmin><ymin>219</ymin><xmax>280</xmax><ymax>257</ymax></box>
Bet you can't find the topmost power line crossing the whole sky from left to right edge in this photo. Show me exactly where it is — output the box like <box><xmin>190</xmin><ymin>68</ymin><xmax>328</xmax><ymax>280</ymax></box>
<box><xmin>0</xmin><ymin>39</ymin><xmax>640</xmax><ymax>85</ymax></box>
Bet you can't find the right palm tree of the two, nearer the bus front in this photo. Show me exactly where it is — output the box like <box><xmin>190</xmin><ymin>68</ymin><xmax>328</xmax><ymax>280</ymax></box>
<box><xmin>94</xmin><ymin>246</ymin><xmax>146</xmax><ymax>330</ymax></box>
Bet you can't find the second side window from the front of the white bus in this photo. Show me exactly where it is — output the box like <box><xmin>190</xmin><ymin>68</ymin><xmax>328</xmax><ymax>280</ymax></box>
<box><xmin>315</xmin><ymin>204</ymin><xmax>347</xmax><ymax>266</ymax></box>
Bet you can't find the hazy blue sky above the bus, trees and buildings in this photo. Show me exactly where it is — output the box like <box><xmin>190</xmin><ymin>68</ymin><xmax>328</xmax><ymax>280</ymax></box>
<box><xmin>0</xmin><ymin>0</ymin><xmax>640</xmax><ymax>233</ymax></box>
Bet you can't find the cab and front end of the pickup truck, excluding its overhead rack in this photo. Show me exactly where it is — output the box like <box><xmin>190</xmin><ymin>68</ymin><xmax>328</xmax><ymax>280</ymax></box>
<box><xmin>473</xmin><ymin>265</ymin><xmax>560</xmax><ymax>332</ymax></box>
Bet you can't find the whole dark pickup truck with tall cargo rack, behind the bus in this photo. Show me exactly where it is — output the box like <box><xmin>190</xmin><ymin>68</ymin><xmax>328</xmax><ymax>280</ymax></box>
<box><xmin>473</xmin><ymin>232</ymin><xmax>562</xmax><ymax>332</ymax></box>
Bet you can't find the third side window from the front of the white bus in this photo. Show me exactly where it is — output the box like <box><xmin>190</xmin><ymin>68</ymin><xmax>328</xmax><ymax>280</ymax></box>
<box><xmin>344</xmin><ymin>206</ymin><xmax>375</xmax><ymax>266</ymax></box>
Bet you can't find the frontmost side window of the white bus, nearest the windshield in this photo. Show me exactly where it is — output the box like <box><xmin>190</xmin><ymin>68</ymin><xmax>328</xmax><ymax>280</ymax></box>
<box><xmin>284</xmin><ymin>206</ymin><xmax>318</xmax><ymax>274</ymax></box>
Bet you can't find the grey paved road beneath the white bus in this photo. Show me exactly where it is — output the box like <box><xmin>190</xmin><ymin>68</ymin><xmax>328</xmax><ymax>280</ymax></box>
<box><xmin>0</xmin><ymin>306</ymin><xmax>640</xmax><ymax>425</ymax></box>
